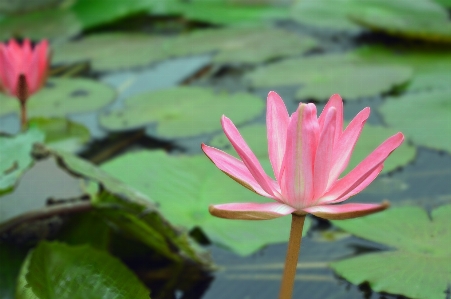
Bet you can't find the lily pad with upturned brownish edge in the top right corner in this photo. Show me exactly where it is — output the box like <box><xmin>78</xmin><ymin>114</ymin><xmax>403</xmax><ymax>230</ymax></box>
<box><xmin>349</xmin><ymin>0</ymin><xmax>451</xmax><ymax>43</ymax></box>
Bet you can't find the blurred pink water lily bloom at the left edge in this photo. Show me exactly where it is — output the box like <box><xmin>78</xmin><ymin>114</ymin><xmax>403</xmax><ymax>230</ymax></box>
<box><xmin>0</xmin><ymin>39</ymin><xmax>49</xmax><ymax>101</ymax></box>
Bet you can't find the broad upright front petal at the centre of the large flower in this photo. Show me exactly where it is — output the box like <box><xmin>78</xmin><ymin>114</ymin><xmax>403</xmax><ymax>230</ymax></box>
<box><xmin>279</xmin><ymin>104</ymin><xmax>319</xmax><ymax>209</ymax></box>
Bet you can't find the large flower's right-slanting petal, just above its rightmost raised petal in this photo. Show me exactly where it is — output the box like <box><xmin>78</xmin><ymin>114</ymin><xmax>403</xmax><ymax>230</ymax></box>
<box><xmin>327</xmin><ymin>107</ymin><xmax>370</xmax><ymax>187</ymax></box>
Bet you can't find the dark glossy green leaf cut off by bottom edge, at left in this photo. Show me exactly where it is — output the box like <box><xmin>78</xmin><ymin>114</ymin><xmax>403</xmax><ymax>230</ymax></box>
<box><xmin>17</xmin><ymin>242</ymin><xmax>149</xmax><ymax>299</ymax></box>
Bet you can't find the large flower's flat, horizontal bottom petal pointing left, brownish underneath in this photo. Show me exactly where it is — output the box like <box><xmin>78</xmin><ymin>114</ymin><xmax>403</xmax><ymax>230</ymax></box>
<box><xmin>208</xmin><ymin>202</ymin><xmax>296</xmax><ymax>220</ymax></box>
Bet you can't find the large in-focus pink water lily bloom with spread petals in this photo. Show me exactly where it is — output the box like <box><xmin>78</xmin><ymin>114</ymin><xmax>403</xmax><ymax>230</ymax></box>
<box><xmin>202</xmin><ymin>92</ymin><xmax>404</xmax><ymax>220</ymax></box>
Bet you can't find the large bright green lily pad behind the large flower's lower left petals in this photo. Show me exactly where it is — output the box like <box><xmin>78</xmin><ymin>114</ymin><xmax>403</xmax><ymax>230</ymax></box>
<box><xmin>102</xmin><ymin>151</ymin><xmax>309</xmax><ymax>255</ymax></box>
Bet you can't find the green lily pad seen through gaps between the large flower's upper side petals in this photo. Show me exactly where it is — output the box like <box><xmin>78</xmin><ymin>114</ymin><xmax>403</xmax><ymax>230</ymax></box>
<box><xmin>209</xmin><ymin>124</ymin><xmax>416</xmax><ymax>173</ymax></box>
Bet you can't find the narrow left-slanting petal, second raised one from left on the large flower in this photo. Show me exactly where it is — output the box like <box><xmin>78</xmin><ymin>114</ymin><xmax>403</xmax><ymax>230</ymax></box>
<box><xmin>221</xmin><ymin>116</ymin><xmax>276</xmax><ymax>197</ymax></box>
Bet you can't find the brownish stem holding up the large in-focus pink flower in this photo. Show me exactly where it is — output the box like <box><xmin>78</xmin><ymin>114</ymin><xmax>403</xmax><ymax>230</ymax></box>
<box><xmin>279</xmin><ymin>214</ymin><xmax>305</xmax><ymax>299</ymax></box>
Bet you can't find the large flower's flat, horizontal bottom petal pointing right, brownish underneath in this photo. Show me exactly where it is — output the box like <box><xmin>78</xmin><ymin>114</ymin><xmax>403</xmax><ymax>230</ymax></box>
<box><xmin>302</xmin><ymin>201</ymin><xmax>390</xmax><ymax>220</ymax></box>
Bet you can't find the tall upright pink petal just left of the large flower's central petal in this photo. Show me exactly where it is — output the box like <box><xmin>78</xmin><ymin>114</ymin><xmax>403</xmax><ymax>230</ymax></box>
<box><xmin>266</xmin><ymin>91</ymin><xmax>290</xmax><ymax>181</ymax></box>
